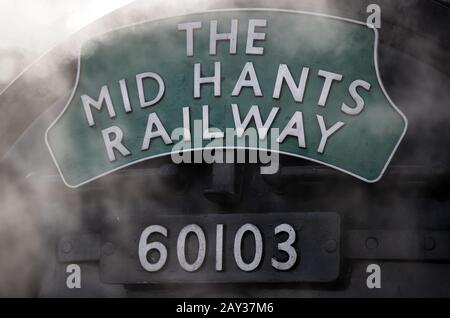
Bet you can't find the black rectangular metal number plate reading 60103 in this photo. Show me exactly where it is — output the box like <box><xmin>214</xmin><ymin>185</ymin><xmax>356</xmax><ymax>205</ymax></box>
<box><xmin>100</xmin><ymin>213</ymin><xmax>340</xmax><ymax>284</ymax></box>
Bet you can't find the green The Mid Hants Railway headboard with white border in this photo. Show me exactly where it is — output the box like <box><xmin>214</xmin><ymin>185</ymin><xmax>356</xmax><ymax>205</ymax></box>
<box><xmin>46</xmin><ymin>9</ymin><xmax>407</xmax><ymax>187</ymax></box>
